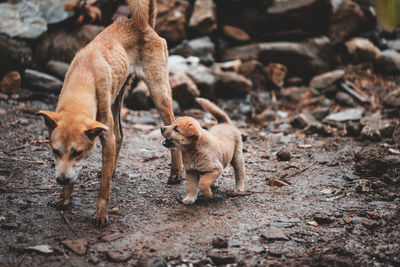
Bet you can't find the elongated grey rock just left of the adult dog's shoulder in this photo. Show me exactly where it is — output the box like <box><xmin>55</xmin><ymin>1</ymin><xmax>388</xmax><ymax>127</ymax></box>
<box><xmin>23</xmin><ymin>69</ymin><xmax>63</xmax><ymax>93</ymax></box>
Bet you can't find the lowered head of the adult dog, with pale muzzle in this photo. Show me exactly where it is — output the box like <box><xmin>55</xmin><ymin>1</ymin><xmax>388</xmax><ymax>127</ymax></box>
<box><xmin>38</xmin><ymin>111</ymin><xmax>108</xmax><ymax>185</ymax></box>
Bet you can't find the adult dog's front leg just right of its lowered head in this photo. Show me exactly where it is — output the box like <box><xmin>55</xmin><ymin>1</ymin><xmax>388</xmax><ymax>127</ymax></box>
<box><xmin>94</xmin><ymin>126</ymin><xmax>116</xmax><ymax>226</ymax></box>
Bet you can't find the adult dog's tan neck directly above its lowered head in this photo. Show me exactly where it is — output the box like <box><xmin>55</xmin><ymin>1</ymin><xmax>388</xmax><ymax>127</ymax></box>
<box><xmin>57</xmin><ymin>73</ymin><xmax>97</xmax><ymax>120</ymax></box>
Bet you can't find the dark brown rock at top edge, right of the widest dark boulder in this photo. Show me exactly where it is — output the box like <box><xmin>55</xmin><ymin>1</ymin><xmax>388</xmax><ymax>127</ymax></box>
<box><xmin>328</xmin><ymin>0</ymin><xmax>368</xmax><ymax>44</ymax></box>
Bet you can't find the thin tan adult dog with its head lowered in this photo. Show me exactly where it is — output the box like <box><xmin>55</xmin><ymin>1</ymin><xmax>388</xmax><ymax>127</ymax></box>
<box><xmin>39</xmin><ymin>0</ymin><xmax>182</xmax><ymax>225</ymax></box>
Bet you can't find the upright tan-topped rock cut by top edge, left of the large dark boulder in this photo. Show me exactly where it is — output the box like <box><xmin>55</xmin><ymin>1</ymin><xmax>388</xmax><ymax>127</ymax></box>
<box><xmin>188</xmin><ymin>0</ymin><xmax>217</xmax><ymax>35</ymax></box>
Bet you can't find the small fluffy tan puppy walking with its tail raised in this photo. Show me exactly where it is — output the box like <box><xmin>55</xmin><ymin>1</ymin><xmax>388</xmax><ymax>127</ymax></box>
<box><xmin>161</xmin><ymin>98</ymin><xmax>245</xmax><ymax>204</ymax></box>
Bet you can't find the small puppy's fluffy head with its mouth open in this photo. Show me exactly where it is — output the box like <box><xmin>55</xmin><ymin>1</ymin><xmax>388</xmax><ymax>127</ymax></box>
<box><xmin>161</xmin><ymin>117</ymin><xmax>201</xmax><ymax>150</ymax></box>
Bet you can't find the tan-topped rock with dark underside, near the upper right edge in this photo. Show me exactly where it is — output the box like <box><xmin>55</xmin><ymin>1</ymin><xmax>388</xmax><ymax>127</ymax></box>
<box><xmin>345</xmin><ymin>37</ymin><xmax>380</xmax><ymax>63</ymax></box>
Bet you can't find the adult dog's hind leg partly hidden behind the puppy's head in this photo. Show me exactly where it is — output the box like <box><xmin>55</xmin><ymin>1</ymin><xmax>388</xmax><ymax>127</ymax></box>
<box><xmin>143</xmin><ymin>38</ymin><xmax>183</xmax><ymax>184</ymax></box>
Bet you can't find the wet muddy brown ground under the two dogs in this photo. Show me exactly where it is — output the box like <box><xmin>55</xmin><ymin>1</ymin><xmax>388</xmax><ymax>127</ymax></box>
<box><xmin>0</xmin><ymin>87</ymin><xmax>400</xmax><ymax>266</ymax></box>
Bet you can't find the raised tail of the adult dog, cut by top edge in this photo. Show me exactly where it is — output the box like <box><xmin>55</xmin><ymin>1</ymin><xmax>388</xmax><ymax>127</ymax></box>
<box><xmin>126</xmin><ymin>0</ymin><xmax>157</xmax><ymax>30</ymax></box>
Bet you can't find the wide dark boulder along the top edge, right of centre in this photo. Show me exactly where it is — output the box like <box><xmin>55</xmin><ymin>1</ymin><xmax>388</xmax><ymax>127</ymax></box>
<box><xmin>216</xmin><ymin>0</ymin><xmax>331</xmax><ymax>41</ymax></box>
